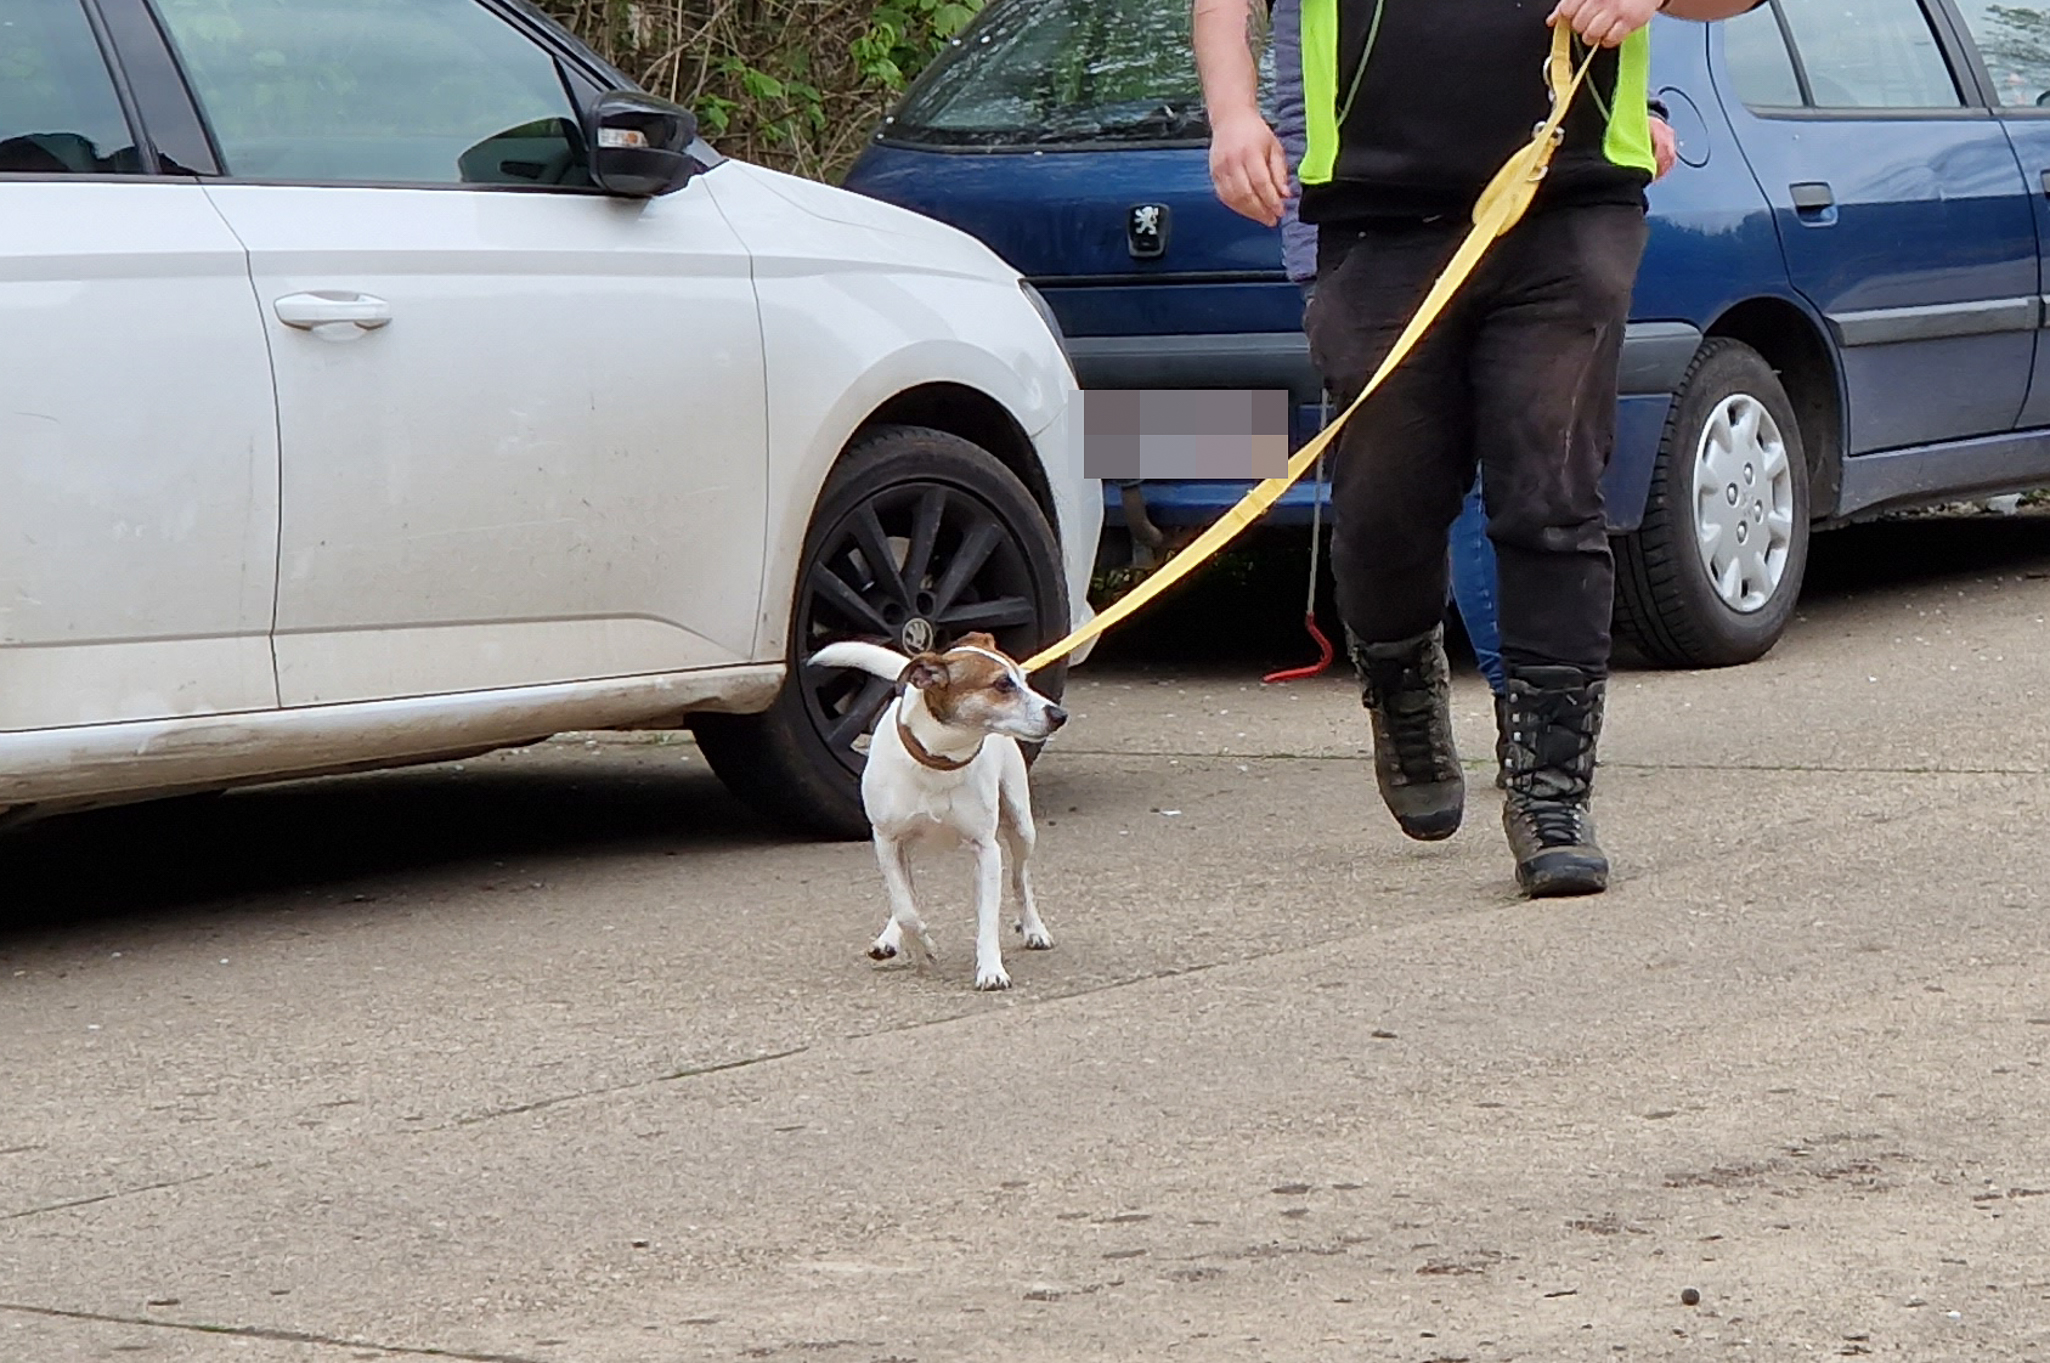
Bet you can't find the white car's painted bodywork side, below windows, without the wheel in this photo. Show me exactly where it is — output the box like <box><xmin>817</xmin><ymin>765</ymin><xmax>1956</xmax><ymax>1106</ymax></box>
<box><xmin>0</xmin><ymin>162</ymin><xmax>1103</xmax><ymax>810</ymax></box>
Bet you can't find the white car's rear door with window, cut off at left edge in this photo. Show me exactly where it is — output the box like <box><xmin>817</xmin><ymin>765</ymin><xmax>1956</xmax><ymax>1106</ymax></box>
<box><xmin>0</xmin><ymin>0</ymin><xmax>277</xmax><ymax>733</ymax></box>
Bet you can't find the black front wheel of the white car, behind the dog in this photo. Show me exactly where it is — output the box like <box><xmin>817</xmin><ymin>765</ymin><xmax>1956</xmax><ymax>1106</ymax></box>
<box><xmin>693</xmin><ymin>426</ymin><xmax>1068</xmax><ymax>838</ymax></box>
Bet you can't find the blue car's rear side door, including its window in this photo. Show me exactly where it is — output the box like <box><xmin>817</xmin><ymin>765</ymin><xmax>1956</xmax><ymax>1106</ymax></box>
<box><xmin>1718</xmin><ymin>0</ymin><xmax>2040</xmax><ymax>455</ymax></box>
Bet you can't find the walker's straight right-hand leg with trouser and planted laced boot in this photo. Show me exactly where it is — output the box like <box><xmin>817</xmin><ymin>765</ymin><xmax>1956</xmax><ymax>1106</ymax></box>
<box><xmin>1474</xmin><ymin>207</ymin><xmax>1646</xmax><ymax>896</ymax></box>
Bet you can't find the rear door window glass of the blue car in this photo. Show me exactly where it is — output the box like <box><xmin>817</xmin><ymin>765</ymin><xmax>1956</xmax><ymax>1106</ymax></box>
<box><xmin>1777</xmin><ymin>0</ymin><xmax>1964</xmax><ymax>109</ymax></box>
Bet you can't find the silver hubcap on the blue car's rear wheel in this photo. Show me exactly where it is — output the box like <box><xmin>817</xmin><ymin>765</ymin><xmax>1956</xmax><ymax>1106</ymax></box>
<box><xmin>1693</xmin><ymin>394</ymin><xmax>1794</xmax><ymax>615</ymax></box>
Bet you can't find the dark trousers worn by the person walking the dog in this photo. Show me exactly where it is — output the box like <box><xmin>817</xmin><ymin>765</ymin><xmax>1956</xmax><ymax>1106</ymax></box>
<box><xmin>1304</xmin><ymin>205</ymin><xmax>1646</xmax><ymax>676</ymax></box>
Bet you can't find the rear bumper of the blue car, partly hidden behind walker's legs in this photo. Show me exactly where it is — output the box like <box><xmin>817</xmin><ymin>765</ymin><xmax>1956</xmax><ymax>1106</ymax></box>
<box><xmin>1068</xmin><ymin>322</ymin><xmax>1702</xmax><ymax>533</ymax></box>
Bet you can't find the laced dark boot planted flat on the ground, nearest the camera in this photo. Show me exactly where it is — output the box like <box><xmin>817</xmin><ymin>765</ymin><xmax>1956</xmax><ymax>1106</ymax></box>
<box><xmin>1499</xmin><ymin>666</ymin><xmax>1609</xmax><ymax>898</ymax></box>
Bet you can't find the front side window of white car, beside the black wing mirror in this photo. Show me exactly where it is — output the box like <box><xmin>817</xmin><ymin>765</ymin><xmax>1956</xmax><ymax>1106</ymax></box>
<box><xmin>158</xmin><ymin>0</ymin><xmax>590</xmax><ymax>187</ymax></box>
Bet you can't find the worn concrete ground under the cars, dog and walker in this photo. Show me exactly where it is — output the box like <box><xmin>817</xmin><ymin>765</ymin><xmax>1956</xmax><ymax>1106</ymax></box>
<box><xmin>0</xmin><ymin>514</ymin><xmax>2050</xmax><ymax>1363</ymax></box>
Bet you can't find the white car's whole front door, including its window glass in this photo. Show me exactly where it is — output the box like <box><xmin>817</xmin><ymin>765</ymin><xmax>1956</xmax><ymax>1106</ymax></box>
<box><xmin>158</xmin><ymin>0</ymin><xmax>767</xmax><ymax>705</ymax></box>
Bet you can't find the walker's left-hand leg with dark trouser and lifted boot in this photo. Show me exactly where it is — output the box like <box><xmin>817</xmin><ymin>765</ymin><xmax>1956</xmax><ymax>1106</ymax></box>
<box><xmin>1306</xmin><ymin>223</ymin><xmax>1474</xmax><ymax>840</ymax></box>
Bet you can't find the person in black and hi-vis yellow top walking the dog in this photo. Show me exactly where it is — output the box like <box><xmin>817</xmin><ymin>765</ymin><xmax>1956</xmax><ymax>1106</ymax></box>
<box><xmin>1195</xmin><ymin>0</ymin><xmax>1759</xmax><ymax>896</ymax></box>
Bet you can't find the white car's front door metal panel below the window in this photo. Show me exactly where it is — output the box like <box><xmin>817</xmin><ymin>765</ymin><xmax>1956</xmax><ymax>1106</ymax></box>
<box><xmin>207</xmin><ymin>184</ymin><xmax>767</xmax><ymax>705</ymax></box>
